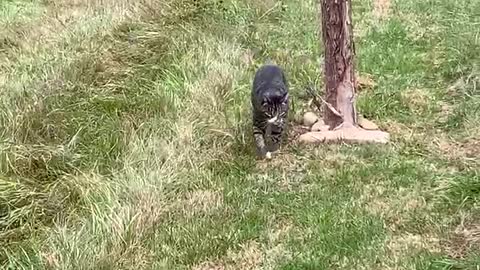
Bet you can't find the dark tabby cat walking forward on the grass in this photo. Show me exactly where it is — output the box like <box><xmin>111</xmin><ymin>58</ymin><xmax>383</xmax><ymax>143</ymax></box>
<box><xmin>251</xmin><ymin>63</ymin><xmax>289</xmax><ymax>158</ymax></box>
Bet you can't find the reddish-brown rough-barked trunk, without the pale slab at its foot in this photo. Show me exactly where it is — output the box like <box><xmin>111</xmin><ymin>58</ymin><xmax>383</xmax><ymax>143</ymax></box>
<box><xmin>320</xmin><ymin>0</ymin><xmax>357</xmax><ymax>129</ymax></box>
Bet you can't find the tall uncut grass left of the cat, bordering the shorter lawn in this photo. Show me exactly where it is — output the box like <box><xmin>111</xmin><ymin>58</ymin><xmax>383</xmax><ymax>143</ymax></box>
<box><xmin>1</xmin><ymin>1</ymin><xmax>258</xmax><ymax>269</ymax></box>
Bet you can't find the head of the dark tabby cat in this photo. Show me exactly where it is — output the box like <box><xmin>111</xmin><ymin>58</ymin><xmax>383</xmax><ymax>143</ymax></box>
<box><xmin>261</xmin><ymin>91</ymin><xmax>288</xmax><ymax>124</ymax></box>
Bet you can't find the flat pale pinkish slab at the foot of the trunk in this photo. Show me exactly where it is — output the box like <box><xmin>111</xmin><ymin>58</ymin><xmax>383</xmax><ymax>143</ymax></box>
<box><xmin>298</xmin><ymin>123</ymin><xmax>390</xmax><ymax>144</ymax></box>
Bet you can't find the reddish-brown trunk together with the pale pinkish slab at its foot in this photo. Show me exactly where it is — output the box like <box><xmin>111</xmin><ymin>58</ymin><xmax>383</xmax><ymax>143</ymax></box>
<box><xmin>299</xmin><ymin>0</ymin><xmax>390</xmax><ymax>143</ymax></box>
